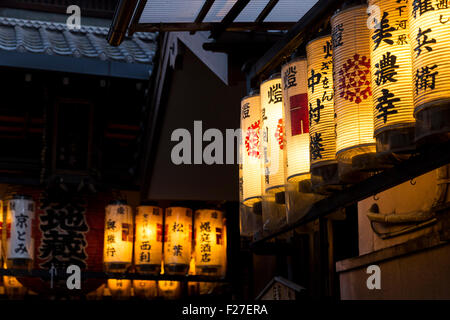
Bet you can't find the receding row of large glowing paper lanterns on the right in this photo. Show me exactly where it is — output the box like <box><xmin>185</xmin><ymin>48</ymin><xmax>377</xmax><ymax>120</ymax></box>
<box><xmin>240</xmin><ymin>0</ymin><xmax>450</xmax><ymax>233</ymax></box>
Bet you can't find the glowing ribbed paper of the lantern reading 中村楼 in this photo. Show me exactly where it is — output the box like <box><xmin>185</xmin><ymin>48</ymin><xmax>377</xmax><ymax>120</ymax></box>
<box><xmin>306</xmin><ymin>35</ymin><xmax>336</xmax><ymax>167</ymax></box>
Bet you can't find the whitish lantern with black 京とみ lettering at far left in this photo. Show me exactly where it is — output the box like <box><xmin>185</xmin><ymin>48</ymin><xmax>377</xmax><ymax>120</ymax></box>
<box><xmin>6</xmin><ymin>195</ymin><xmax>35</xmax><ymax>269</ymax></box>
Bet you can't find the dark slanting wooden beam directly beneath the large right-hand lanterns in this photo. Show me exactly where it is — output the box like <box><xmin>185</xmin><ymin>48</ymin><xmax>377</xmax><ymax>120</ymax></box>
<box><xmin>251</xmin><ymin>142</ymin><xmax>450</xmax><ymax>248</ymax></box>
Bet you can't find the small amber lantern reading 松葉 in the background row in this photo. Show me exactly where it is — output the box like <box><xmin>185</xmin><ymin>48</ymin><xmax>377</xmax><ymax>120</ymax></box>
<box><xmin>164</xmin><ymin>207</ymin><xmax>192</xmax><ymax>275</ymax></box>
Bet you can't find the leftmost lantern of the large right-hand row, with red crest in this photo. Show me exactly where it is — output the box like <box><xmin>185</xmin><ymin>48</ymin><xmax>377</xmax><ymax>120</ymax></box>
<box><xmin>241</xmin><ymin>94</ymin><xmax>262</xmax><ymax>207</ymax></box>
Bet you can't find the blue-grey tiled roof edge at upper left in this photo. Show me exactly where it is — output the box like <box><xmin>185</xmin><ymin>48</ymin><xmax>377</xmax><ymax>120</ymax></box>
<box><xmin>0</xmin><ymin>17</ymin><xmax>156</xmax><ymax>64</ymax></box>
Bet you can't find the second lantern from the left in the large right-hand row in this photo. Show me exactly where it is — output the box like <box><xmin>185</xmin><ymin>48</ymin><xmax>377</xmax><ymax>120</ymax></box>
<box><xmin>260</xmin><ymin>76</ymin><xmax>284</xmax><ymax>192</ymax></box>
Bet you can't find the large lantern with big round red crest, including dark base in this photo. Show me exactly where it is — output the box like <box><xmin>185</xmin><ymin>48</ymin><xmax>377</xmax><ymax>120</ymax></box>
<box><xmin>331</xmin><ymin>5</ymin><xmax>376</xmax><ymax>181</ymax></box>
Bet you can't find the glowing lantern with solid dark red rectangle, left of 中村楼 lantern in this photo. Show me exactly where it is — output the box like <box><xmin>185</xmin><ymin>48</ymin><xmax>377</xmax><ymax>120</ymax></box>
<box><xmin>281</xmin><ymin>58</ymin><xmax>310</xmax><ymax>182</ymax></box>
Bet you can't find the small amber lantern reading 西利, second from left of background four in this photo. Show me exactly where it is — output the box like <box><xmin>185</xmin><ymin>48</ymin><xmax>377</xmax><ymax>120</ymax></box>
<box><xmin>134</xmin><ymin>205</ymin><xmax>163</xmax><ymax>274</ymax></box>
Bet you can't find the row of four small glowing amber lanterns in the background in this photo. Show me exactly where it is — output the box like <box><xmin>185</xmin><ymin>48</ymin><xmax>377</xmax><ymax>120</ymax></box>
<box><xmin>103</xmin><ymin>201</ymin><xmax>227</xmax><ymax>276</ymax></box>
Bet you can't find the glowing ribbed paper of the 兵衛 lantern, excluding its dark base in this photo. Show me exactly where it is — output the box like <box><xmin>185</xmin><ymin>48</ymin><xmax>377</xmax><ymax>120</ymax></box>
<box><xmin>408</xmin><ymin>0</ymin><xmax>450</xmax><ymax>112</ymax></box>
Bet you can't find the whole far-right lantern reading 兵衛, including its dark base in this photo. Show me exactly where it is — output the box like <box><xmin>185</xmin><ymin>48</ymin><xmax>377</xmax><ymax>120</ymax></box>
<box><xmin>408</xmin><ymin>0</ymin><xmax>450</xmax><ymax>143</ymax></box>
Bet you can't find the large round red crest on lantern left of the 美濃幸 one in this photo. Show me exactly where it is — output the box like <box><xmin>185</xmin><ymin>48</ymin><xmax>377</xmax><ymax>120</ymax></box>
<box><xmin>339</xmin><ymin>54</ymin><xmax>372</xmax><ymax>104</ymax></box>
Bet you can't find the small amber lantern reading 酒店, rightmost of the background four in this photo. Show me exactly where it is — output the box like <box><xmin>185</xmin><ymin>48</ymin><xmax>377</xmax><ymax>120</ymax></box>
<box><xmin>194</xmin><ymin>209</ymin><xmax>227</xmax><ymax>276</ymax></box>
